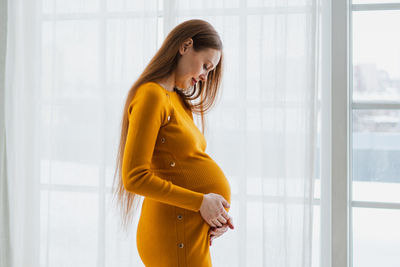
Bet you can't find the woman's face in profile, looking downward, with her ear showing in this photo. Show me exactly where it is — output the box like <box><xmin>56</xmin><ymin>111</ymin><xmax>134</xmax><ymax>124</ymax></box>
<box><xmin>175</xmin><ymin>38</ymin><xmax>221</xmax><ymax>89</ymax></box>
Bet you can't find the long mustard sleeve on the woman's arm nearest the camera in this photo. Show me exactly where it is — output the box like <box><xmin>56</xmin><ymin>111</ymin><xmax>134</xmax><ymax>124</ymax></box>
<box><xmin>122</xmin><ymin>85</ymin><xmax>204</xmax><ymax>211</ymax></box>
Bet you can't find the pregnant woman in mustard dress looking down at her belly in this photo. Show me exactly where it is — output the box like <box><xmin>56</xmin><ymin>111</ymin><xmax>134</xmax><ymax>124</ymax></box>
<box><xmin>114</xmin><ymin>19</ymin><xmax>234</xmax><ymax>267</ymax></box>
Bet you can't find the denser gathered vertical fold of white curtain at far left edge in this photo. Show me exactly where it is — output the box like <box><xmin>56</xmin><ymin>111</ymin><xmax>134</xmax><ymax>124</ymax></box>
<box><xmin>3</xmin><ymin>0</ymin><xmax>40</xmax><ymax>266</ymax></box>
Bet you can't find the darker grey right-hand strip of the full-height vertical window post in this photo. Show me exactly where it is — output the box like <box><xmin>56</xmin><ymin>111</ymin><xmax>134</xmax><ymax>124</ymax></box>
<box><xmin>331</xmin><ymin>0</ymin><xmax>351</xmax><ymax>267</ymax></box>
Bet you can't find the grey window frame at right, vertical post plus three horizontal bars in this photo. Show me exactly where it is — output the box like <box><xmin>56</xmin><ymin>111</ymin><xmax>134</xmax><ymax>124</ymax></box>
<box><xmin>320</xmin><ymin>0</ymin><xmax>400</xmax><ymax>267</ymax></box>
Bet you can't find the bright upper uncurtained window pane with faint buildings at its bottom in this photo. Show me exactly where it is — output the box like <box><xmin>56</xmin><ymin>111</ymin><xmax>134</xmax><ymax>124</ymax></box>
<box><xmin>353</xmin><ymin>10</ymin><xmax>400</xmax><ymax>101</ymax></box>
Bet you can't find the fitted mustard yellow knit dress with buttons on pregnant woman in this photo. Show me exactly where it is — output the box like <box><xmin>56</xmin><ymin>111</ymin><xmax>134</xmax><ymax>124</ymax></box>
<box><xmin>122</xmin><ymin>82</ymin><xmax>231</xmax><ymax>267</ymax></box>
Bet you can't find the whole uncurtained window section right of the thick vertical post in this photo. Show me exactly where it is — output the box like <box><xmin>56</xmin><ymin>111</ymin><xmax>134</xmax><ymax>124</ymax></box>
<box><xmin>349</xmin><ymin>0</ymin><xmax>400</xmax><ymax>267</ymax></box>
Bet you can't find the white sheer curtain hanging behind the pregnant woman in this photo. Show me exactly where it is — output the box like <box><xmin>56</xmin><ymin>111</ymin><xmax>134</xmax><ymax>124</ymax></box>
<box><xmin>0</xmin><ymin>0</ymin><xmax>319</xmax><ymax>267</ymax></box>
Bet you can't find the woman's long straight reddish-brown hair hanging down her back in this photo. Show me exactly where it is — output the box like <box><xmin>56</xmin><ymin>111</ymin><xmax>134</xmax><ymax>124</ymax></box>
<box><xmin>113</xmin><ymin>19</ymin><xmax>223</xmax><ymax>230</ymax></box>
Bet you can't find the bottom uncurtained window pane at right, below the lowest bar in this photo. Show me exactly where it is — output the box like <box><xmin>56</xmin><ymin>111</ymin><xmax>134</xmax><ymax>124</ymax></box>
<box><xmin>353</xmin><ymin>208</ymin><xmax>400</xmax><ymax>267</ymax></box>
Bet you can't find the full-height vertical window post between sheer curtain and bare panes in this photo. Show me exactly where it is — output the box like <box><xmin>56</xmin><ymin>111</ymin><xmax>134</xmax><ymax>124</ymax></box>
<box><xmin>320</xmin><ymin>0</ymin><xmax>351</xmax><ymax>267</ymax></box>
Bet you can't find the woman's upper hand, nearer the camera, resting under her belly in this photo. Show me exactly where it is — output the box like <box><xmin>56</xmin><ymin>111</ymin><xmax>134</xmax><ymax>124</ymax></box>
<box><xmin>200</xmin><ymin>193</ymin><xmax>233</xmax><ymax>229</ymax></box>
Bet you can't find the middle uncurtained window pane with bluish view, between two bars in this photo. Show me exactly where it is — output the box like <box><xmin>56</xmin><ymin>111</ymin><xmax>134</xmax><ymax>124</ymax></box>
<box><xmin>353</xmin><ymin>110</ymin><xmax>400</xmax><ymax>202</ymax></box>
